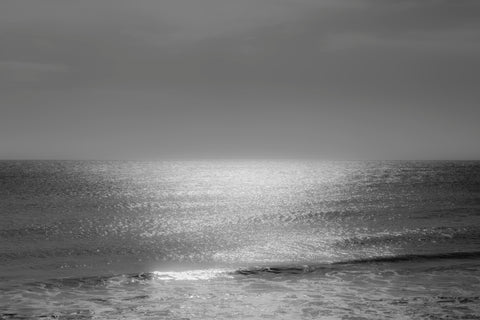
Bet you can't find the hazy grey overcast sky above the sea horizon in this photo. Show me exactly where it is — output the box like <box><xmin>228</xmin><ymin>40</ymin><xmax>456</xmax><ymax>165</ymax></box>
<box><xmin>0</xmin><ymin>0</ymin><xmax>480</xmax><ymax>160</ymax></box>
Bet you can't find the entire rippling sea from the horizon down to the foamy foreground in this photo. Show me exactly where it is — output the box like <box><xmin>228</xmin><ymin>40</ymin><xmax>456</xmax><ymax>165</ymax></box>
<box><xmin>0</xmin><ymin>161</ymin><xmax>480</xmax><ymax>319</ymax></box>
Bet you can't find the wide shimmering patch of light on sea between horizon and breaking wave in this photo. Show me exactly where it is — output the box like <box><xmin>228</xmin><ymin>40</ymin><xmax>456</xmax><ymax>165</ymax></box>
<box><xmin>132</xmin><ymin>161</ymin><xmax>370</xmax><ymax>268</ymax></box>
